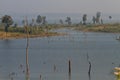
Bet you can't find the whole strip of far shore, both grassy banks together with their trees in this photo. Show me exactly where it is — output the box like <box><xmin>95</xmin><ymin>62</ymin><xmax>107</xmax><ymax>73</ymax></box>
<box><xmin>0</xmin><ymin>12</ymin><xmax>120</xmax><ymax>39</ymax></box>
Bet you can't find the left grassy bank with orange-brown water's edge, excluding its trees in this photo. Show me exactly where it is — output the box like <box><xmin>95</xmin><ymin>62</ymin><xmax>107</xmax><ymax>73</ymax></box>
<box><xmin>0</xmin><ymin>26</ymin><xmax>64</xmax><ymax>39</ymax></box>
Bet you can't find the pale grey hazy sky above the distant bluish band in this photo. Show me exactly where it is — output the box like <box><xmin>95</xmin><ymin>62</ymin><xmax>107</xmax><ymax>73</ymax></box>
<box><xmin>0</xmin><ymin>0</ymin><xmax>120</xmax><ymax>14</ymax></box>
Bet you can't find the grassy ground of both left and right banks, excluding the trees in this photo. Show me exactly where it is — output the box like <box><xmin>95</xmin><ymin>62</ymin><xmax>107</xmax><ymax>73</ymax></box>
<box><xmin>0</xmin><ymin>23</ymin><xmax>120</xmax><ymax>39</ymax></box>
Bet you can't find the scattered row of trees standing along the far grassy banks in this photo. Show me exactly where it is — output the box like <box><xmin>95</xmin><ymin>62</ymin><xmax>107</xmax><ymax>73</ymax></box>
<box><xmin>0</xmin><ymin>12</ymin><xmax>112</xmax><ymax>32</ymax></box>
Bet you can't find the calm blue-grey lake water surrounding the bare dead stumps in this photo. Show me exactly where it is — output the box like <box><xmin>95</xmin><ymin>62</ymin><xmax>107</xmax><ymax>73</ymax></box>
<box><xmin>0</xmin><ymin>29</ymin><xmax>120</xmax><ymax>80</ymax></box>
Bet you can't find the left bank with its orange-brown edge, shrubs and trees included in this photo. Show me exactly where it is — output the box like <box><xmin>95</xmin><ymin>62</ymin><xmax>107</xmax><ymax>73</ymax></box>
<box><xmin>0</xmin><ymin>15</ymin><xmax>64</xmax><ymax>39</ymax></box>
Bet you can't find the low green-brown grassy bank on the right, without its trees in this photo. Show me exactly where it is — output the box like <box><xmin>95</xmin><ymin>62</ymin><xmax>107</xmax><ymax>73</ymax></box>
<box><xmin>74</xmin><ymin>23</ymin><xmax>120</xmax><ymax>33</ymax></box>
